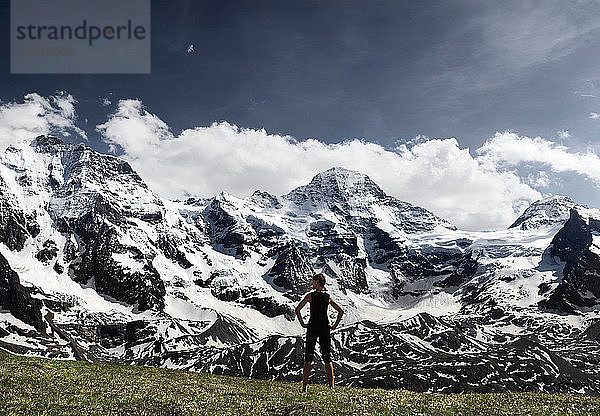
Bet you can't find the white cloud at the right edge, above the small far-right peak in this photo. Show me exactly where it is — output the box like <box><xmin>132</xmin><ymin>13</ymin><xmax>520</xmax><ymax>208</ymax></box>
<box><xmin>477</xmin><ymin>132</ymin><xmax>600</xmax><ymax>186</ymax></box>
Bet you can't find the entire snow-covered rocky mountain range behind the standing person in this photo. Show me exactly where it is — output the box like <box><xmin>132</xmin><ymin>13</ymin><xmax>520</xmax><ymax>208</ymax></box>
<box><xmin>0</xmin><ymin>136</ymin><xmax>600</xmax><ymax>394</ymax></box>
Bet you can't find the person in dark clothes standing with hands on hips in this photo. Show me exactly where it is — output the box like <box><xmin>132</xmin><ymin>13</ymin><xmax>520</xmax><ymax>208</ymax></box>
<box><xmin>296</xmin><ymin>273</ymin><xmax>344</xmax><ymax>391</ymax></box>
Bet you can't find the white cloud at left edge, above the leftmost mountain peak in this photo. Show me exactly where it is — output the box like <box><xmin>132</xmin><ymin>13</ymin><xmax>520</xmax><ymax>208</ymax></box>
<box><xmin>0</xmin><ymin>93</ymin><xmax>87</xmax><ymax>150</ymax></box>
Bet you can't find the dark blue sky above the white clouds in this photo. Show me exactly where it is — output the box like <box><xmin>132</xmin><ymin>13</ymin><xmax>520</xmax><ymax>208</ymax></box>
<box><xmin>0</xmin><ymin>1</ymin><xmax>600</xmax><ymax>153</ymax></box>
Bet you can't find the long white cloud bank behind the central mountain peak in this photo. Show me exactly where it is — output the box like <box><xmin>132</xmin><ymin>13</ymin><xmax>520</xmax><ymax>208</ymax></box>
<box><xmin>97</xmin><ymin>100</ymin><xmax>541</xmax><ymax>229</ymax></box>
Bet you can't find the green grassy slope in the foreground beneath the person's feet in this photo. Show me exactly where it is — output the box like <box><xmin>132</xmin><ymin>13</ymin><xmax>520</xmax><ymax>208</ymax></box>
<box><xmin>0</xmin><ymin>352</ymin><xmax>600</xmax><ymax>416</ymax></box>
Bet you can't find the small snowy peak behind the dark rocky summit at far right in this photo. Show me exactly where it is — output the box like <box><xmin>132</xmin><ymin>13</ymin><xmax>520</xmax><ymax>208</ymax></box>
<box><xmin>508</xmin><ymin>195</ymin><xmax>577</xmax><ymax>230</ymax></box>
